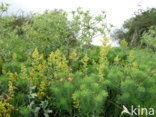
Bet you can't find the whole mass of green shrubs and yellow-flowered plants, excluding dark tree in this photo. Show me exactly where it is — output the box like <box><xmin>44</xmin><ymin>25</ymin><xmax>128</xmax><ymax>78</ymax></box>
<box><xmin>0</xmin><ymin>4</ymin><xmax>156</xmax><ymax>117</ymax></box>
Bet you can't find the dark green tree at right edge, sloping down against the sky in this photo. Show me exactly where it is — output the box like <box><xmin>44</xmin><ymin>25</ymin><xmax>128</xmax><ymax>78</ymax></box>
<box><xmin>113</xmin><ymin>8</ymin><xmax>156</xmax><ymax>49</ymax></box>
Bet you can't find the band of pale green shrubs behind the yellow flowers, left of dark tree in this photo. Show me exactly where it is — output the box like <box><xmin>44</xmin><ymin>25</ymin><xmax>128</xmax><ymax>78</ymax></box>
<box><xmin>0</xmin><ymin>5</ymin><xmax>107</xmax><ymax>61</ymax></box>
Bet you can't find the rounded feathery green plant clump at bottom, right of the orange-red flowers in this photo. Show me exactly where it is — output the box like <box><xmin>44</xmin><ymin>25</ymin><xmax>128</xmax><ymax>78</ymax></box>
<box><xmin>72</xmin><ymin>75</ymin><xmax>107</xmax><ymax>116</ymax></box>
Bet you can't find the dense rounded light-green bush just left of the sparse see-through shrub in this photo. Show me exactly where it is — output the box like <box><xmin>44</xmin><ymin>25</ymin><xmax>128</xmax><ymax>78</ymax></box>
<box><xmin>22</xmin><ymin>11</ymin><xmax>70</xmax><ymax>54</ymax></box>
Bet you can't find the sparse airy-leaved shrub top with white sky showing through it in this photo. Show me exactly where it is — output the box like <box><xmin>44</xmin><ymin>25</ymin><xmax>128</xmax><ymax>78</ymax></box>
<box><xmin>70</xmin><ymin>8</ymin><xmax>107</xmax><ymax>48</ymax></box>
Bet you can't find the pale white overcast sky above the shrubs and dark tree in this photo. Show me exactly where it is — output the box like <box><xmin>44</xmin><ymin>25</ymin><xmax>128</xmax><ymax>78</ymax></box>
<box><xmin>0</xmin><ymin>0</ymin><xmax>156</xmax><ymax>45</ymax></box>
